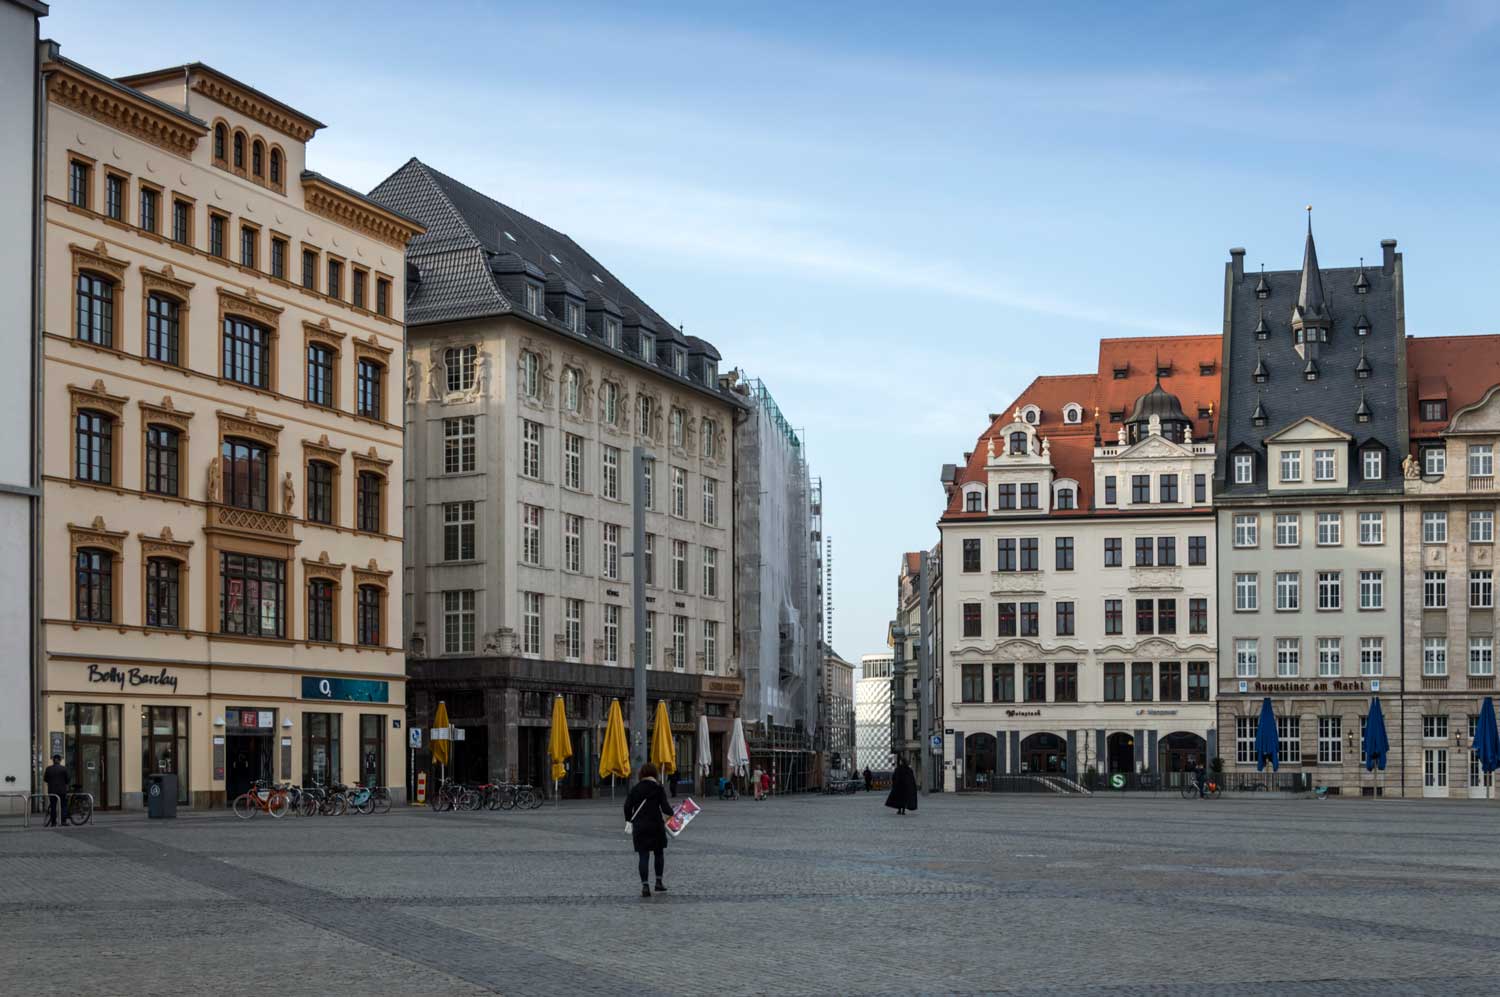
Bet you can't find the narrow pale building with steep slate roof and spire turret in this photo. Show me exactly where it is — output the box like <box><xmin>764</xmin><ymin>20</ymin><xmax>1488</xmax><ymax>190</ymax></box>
<box><xmin>1215</xmin><ymin>226</ymin><xmax>1409</xmax><ymax>792</ymax></box>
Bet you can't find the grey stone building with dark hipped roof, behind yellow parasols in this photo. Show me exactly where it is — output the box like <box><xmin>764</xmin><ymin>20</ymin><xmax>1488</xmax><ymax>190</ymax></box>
<box><xmin>371</xmin><ymin>159</ymin><xmax>744</xmax><ymax>796</ymax></box>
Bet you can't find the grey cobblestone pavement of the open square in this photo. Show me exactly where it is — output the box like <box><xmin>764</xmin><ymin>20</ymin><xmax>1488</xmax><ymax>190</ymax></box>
<box><xmin>0</xmin><ymin>793</ymin><xmax>1500</xmax><ymax>997</ymax></box>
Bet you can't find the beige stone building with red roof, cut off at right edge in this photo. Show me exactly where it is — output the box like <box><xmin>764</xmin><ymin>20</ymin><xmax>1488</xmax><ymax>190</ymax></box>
<box><xmin>1388</xmin><ymin>336</ymin><xmax>1500</xmax><ymax>798</ymax></box>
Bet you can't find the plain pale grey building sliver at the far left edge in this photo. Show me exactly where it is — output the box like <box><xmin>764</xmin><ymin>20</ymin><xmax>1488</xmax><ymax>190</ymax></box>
<box><xmin>0</xmin><ymin>0</ymin><xmax>47</xmax><ymax>793</ymax></box>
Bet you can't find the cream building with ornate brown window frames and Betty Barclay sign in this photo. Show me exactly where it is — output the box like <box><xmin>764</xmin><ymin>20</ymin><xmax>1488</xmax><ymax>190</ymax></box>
<box><xmin>38</xmin><ymin>46</ymin><xmax>420</xmax><ymax>807</ymax></box>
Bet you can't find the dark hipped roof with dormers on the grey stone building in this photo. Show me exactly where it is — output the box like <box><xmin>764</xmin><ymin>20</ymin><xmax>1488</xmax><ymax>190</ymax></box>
<box><xmin>369</xmin><ymin>157</ymin><xmax>734</xmax><ymax>400</ymax></box>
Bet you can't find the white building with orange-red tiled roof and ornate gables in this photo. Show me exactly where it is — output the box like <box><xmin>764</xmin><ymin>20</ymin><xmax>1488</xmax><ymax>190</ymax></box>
<box><xmin>939</xmin><ymin>336</ymin><xmax>1220</xmax><ymax>789</ymax></box>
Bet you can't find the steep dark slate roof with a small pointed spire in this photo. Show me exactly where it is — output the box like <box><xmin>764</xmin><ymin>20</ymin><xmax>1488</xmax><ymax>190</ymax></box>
<box><xmin>1217</xmin><ymin>227</ymin><xmax>1407</xmax><ymax>498</ymax></box>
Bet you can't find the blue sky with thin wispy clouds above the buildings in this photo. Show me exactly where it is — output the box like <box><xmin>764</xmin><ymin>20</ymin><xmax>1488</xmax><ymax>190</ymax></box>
<box><xmin>42</xmin><ymin>0</ymin><xmax>1500</xmax><ymax>660</ymax></box>
